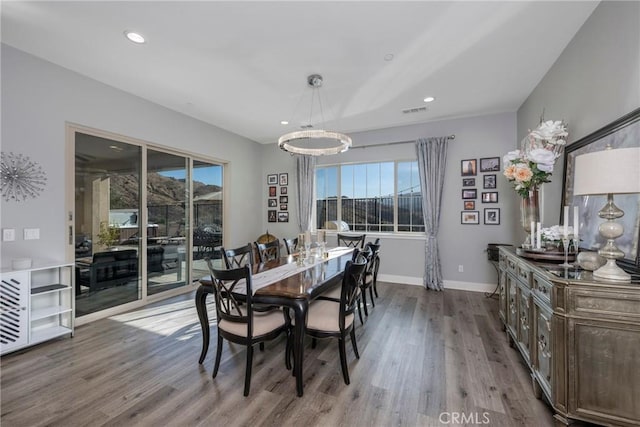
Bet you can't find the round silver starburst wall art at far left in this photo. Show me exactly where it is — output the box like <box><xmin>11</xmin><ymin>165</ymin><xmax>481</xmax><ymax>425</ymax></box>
<box><xmin>1</xmin><ymin>153</ymin><xmax>47</xmax><ymax>202</ymax></box>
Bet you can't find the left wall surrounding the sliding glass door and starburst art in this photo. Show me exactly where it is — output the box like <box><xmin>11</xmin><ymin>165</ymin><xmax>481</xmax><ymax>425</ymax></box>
<box><xmin>1</xmin><ymin>45</ymin><xmax>262</xmax><ymax>266</ymax></box>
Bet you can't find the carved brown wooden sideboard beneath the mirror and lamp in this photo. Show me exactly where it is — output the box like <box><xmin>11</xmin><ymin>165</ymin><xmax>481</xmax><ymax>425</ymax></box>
<box><xmin>499</xmin><ymin>247</ymin><xmax>640</xmax><ymax>426</ymax></box>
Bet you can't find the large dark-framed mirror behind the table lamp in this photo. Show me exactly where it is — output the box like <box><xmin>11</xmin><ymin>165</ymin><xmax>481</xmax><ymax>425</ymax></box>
<box><xmin>560</xmin><ymin>108</ymin><xmax>640</xmax><ymax>273</ymax></box>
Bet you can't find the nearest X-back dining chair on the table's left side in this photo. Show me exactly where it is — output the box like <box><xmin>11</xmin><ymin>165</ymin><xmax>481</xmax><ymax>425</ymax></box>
<box><xmin>207</xmin><ymin>259</ymin><xmax>291</xmax><ymax>396</ymax></box>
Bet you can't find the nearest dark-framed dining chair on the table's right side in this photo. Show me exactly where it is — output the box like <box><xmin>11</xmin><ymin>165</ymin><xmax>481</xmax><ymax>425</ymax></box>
<box><xmin>296</xmin><ymin>257</ymin><xmax>366</xmax><ymax>385</ymax></box>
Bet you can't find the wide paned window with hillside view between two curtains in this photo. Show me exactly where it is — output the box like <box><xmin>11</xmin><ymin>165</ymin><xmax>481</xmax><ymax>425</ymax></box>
<box><xmin>316</xmin><ymin>161</ymin><xmax>424</xmax><ymax>232</ymax></box>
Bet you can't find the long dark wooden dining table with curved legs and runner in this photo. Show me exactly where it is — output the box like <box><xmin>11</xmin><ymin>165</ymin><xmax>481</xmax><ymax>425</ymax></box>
<box><xmin>195</xmin><ymin>247</ymin><xmax>354</xmax><ymax>397</ymax></box>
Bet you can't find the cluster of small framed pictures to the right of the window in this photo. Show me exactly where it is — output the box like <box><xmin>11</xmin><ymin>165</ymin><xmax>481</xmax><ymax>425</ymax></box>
<box><xmin>460</xmin><ymin>157</ymin><xmax>500</xmax><ymax>225</ymax></box>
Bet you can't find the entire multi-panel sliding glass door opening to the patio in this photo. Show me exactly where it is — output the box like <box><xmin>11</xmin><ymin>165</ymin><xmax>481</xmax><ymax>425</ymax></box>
<box><xmin>69</xmin><ymin>127</ymin><xmax>224</xmax><ymax>320</ymax></box>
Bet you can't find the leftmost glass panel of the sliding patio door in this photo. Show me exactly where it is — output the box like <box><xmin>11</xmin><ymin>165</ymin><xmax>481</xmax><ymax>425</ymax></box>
<box><xmin>75</xmin><ymin>133</ymin><xmax>142</xmax><ymax>317</ymax></box>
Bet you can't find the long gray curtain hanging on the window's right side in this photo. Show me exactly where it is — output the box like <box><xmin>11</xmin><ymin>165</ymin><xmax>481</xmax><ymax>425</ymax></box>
<box><xmin>416</xmin><ymin>136</ymin><xmax>449</xmax><ymax>291</ymax></box>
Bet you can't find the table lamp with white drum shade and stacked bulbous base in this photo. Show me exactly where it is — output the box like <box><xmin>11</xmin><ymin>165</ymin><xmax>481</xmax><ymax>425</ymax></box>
<box><xmin>573</xmin><ymin>146</ymin><xmax>640</xmax><ymax>282</ymax></box>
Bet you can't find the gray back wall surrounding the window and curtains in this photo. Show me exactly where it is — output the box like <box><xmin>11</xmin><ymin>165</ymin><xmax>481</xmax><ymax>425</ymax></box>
<box><xmin>262</xmin><ymin>113</ymin><xmax>520</xmax><ymax>289</ymax></box>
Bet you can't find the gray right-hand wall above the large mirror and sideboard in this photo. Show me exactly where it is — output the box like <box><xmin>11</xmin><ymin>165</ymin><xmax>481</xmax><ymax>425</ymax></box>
<box><xmin>518</xmin><ymin>1</ymin><xmax>640</xmax><ymax>226</ymax></box>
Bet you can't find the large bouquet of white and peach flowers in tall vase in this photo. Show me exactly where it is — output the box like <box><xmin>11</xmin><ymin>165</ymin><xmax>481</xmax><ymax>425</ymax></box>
<box><xmin>503</xmin><ymin>120</ymin><xmax>569</xmax><ymax>198</ymax></box>
